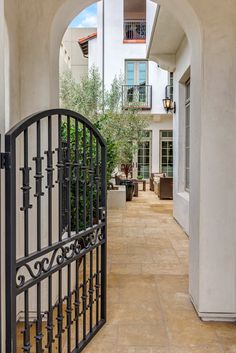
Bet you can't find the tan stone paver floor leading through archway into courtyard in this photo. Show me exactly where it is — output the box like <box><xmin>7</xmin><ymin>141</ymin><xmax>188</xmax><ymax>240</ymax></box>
<box><xmin>84</xmin><ymin>191</ymin><xmax>236</xmax><ymax>353</ymax></box>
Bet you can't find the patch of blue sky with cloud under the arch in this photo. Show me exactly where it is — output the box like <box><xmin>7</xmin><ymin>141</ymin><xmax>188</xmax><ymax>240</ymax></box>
<box><xmin>69</xmin><ymin>3</ymin><xmax>97</xmax><ymax>28</ymax></box>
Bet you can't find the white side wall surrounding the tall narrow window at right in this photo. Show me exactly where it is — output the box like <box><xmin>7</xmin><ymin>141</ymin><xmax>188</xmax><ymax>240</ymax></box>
<box><xmin>173</xmin><ymin>38</ymin><xmax>191</xmax><ymax>234</ymax></box>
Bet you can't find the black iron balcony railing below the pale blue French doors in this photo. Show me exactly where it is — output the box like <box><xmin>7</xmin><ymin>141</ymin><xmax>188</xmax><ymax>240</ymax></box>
<box><xmin>122</xmin><ymin>85</ymin><xmax>152</xmax><ymax>110</ymax></box>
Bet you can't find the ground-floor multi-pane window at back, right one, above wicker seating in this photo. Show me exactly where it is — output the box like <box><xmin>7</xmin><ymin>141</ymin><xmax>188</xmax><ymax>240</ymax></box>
<box><xmin>160</xmin><ymin>130</ymin><xmax>173</xmax><ymax>177</ymax></box>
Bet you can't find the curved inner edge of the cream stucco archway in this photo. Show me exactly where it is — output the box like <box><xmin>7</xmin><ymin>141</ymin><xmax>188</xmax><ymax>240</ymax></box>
<box><xmin>50</xmin><ymin>0</ymin><xmax>202</xmax><ymax>316</ymax></box>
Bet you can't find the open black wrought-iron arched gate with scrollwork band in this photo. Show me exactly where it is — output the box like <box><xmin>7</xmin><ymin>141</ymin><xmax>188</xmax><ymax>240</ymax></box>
<box><xmin>4</xmin><ymin>109</ymin><xmax>106</xmax><ymax>353</ymax></box>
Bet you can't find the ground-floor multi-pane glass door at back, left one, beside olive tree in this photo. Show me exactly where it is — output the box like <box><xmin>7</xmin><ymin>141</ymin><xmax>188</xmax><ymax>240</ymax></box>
<box><xmin>138</xmin><ymin>130</ymin><xmax>152</xmax><ymax>179</ymax></box>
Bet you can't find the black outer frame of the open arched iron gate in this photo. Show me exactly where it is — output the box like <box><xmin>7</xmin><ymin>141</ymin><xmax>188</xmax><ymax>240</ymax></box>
<box><xmin>3</xmin><ymin>108</ymin><xmax>107</xmax><ymax>353</ymax></box>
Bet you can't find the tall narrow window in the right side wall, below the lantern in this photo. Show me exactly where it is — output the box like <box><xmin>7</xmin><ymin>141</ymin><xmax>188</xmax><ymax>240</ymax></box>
<box><xmin>185</xmin><ymin>80</ymin><xmax>190</xmax><ymax>191</ymax></box>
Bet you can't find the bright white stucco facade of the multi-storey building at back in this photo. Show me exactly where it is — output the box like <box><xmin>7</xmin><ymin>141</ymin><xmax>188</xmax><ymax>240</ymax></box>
<box><xmin>93</xmin><ymin>0</ymin><xmax>172</xmax><ymax>172</ymax></box>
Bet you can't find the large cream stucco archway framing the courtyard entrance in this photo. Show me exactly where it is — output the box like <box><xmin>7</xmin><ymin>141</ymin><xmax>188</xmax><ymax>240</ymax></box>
<box><xmin>5</xmin><ymin>0</ymin><xmax>236</xmax><ymax>318</ymax></box>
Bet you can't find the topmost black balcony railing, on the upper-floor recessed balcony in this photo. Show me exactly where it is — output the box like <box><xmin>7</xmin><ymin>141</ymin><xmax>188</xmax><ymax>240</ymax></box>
<box><xmin>124</xmin><ymin>20</ymin><xmax>146</xmax><ymax>40</ymax></box>
